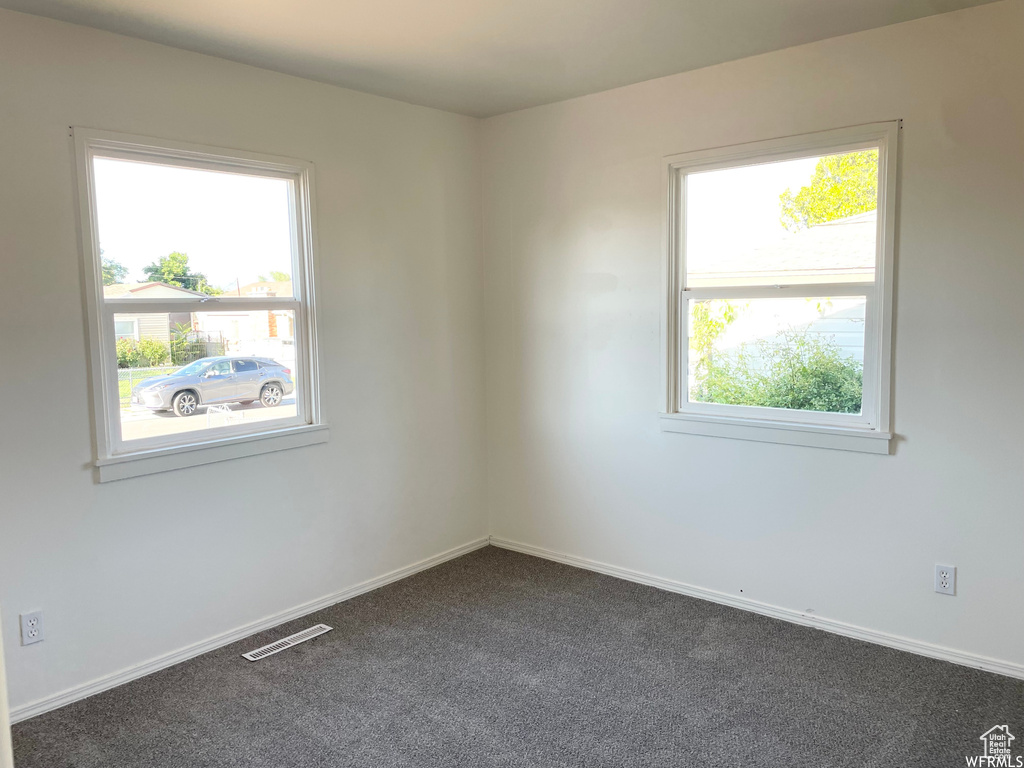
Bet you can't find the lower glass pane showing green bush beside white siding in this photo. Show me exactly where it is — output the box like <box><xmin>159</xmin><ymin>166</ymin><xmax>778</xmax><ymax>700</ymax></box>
<box><xmin>687</xmin><ymin>296</ymin><xmax>865</xmax><ymax>414</ymax></box>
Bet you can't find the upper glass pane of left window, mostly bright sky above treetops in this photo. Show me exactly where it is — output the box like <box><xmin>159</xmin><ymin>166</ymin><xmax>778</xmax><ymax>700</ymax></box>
<box><xmin>93</xmin><ymin>158</ymin><xmax>294</xmax><ymax>299</ymax></box>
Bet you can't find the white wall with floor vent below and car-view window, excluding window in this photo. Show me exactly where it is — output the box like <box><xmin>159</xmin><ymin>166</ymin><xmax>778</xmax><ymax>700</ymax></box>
<box><xmin>0</xmin><ymin>10</ymin><xmax>485</xmax><ymax>708</ymax></box>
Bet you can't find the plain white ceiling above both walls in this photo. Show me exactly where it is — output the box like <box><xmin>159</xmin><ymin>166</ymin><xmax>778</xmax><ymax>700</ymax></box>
<box><xmin>0</xmin><ymin>0</ymin><xmax>989</xmax><ymax>117</ymax></box>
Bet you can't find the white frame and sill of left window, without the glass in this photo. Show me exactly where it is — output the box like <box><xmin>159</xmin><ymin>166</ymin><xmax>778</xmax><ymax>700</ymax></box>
<box><xmin>72</xmin><ymin>132</ymin><xmax>328</xmax><ymax>482</ymax></box>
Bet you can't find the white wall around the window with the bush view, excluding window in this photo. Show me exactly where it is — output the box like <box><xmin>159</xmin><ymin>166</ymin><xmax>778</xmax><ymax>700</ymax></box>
<box><xmin>483</xmin><ymin>0</ymin><xmax>1024</xmax><ymax>664</ymax></box>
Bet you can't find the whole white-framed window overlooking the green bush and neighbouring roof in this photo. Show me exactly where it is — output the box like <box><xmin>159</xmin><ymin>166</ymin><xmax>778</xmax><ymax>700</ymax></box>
<box><xmin>662</xmin><ymin>123</ymin><xmax>899</xmax><ymax>453</ymax></box>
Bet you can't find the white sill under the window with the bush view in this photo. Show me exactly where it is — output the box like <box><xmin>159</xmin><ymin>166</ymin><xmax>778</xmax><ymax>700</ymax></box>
<box><xmin>660</xmin><ymin>414</ymin><xmax>892</xmax><ymax>454</ymax></box>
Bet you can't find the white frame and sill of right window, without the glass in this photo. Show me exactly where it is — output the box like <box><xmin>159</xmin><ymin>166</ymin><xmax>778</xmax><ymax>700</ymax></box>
<box><xmin>660</xmin><ymin>121</ymin><xmax>900</xmax><ymax>454</ymax></box>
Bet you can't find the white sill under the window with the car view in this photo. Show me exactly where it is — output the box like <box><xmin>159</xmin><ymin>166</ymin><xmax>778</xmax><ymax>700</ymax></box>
<box><xmin>96</xmin><ymin>424</ymin><xmax>329</xmax><ymax>482</ymax></box>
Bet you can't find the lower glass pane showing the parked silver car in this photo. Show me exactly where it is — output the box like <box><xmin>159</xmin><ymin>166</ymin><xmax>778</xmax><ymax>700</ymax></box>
<box><xmin>115</xmin><ymin>310</ymin><xmax>301</xmax><ymax>442</ymax></box>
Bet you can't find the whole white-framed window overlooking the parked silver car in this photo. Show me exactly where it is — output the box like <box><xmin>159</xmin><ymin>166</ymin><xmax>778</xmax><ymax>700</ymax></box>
<box><xmin>75</xmin><ymin>129</ymin><xmax>327</xmax><ymax>481</ymax></box>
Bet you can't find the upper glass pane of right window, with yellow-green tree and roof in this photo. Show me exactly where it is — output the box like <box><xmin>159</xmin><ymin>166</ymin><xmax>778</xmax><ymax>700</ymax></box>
<box><xmin>685</xmin><ymin>150</ymin><xmax>879</xmax><ymax>288</ymax></box>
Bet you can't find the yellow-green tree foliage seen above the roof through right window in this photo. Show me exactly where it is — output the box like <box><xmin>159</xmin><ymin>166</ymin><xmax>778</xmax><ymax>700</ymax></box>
<box><xmin>778</xmin><ymin>150</ymin><xmax>879</xmax><ymax>230</ymax></box>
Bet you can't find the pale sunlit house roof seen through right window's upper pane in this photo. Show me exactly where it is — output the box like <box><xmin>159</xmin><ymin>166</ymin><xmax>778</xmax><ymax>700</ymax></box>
<box><xmin>687</xmin><ymin>211</ymin><xmax>878</xmax><ymax>285</ymax></box>
